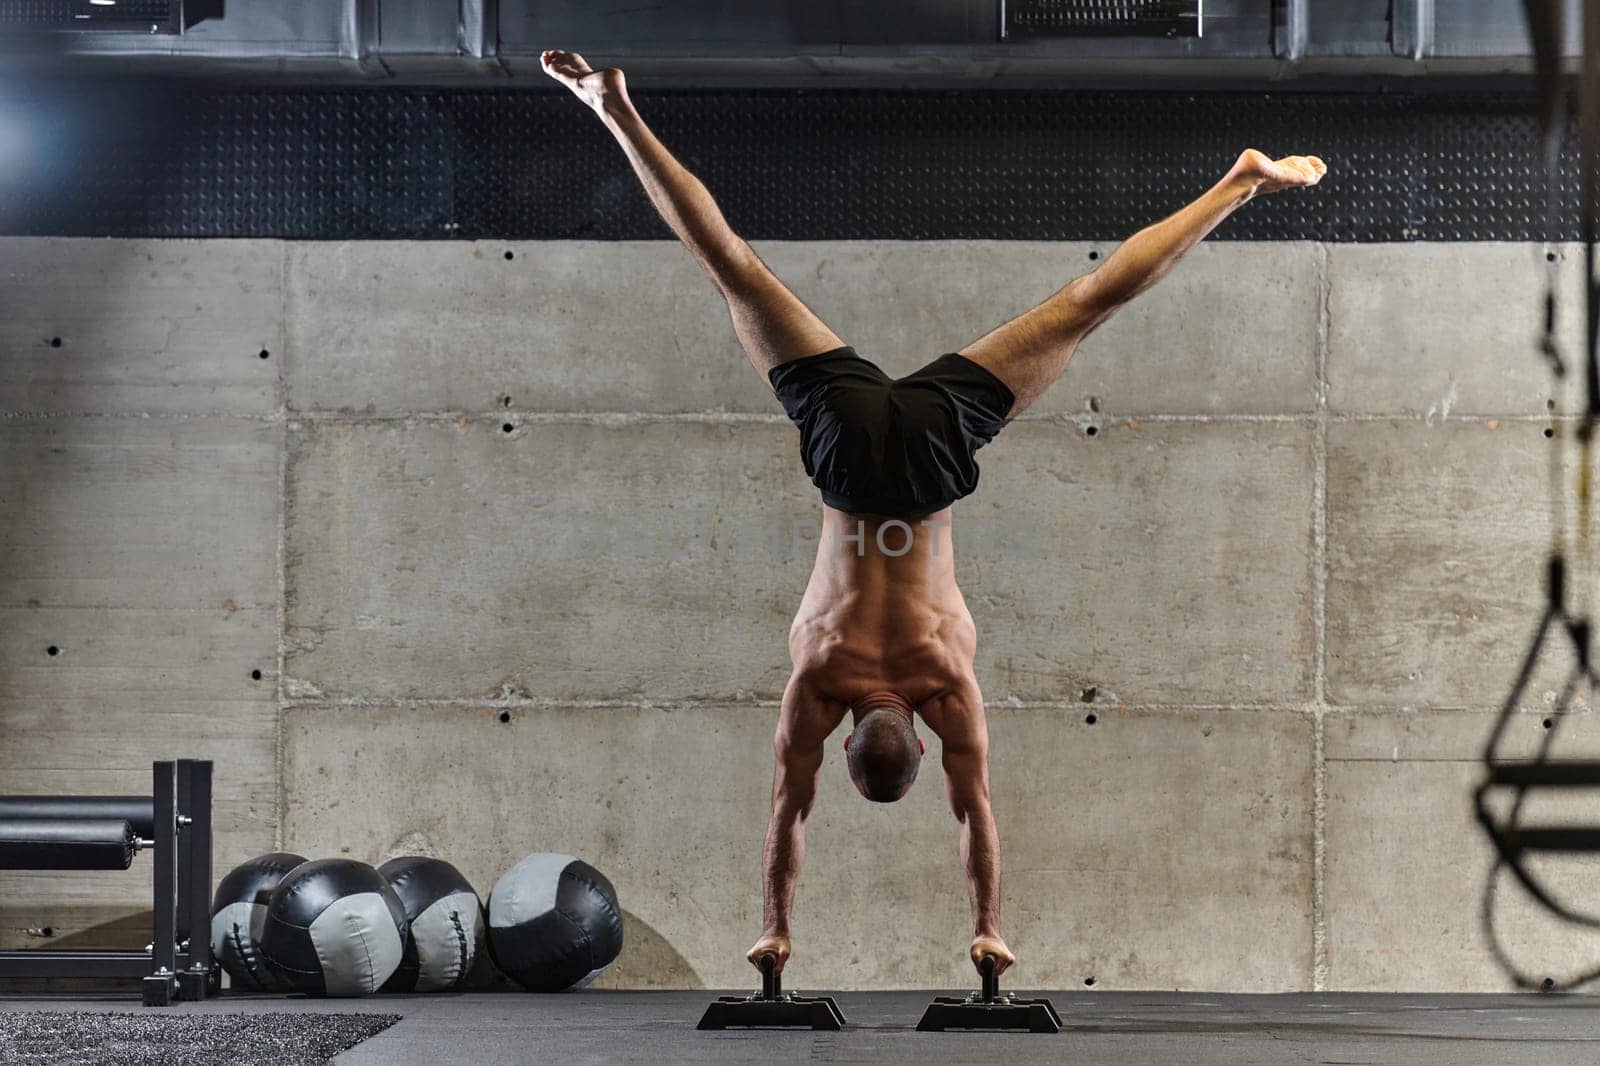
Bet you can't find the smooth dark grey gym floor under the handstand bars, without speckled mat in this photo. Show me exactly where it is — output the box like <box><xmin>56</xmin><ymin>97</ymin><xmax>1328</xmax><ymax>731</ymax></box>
<box><xmin>0</xmin><ymin>989</ymin><xmax>1600</xmax><ymax>1066</ymax></box>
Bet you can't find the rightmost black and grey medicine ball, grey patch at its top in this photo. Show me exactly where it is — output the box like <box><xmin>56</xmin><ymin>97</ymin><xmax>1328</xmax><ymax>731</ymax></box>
<box><xmin>488</xmin><ymin>852</ymin><xmax>622</xmax><ymax>992</ymax></box>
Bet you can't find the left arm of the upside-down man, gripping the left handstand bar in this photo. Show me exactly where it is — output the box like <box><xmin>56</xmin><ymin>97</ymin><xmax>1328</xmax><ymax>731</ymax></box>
<box><xmin>746</xmin><ymin>680</ymin><xmax>845</xmax><ymax>973</ymax></box>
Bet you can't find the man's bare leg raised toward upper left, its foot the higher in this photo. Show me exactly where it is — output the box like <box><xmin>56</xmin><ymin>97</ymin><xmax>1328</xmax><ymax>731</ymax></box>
<box><xmin>541</xmin><ymin>51</ymin><xmax>845</xmax><ymax>378</ymax></box>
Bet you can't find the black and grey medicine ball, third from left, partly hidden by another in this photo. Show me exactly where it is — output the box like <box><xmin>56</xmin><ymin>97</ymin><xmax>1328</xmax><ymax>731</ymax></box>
<box><xmin>378</xmin><ymin>855</ymin><xmax>483</xmax><ymax>992</ymax></box>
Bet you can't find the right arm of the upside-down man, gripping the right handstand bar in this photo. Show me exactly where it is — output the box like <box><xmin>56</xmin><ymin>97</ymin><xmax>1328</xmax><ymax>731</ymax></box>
<box><xmin>939</xmin><ymin>683</ymin><xmax>1016</xmax><ymax>973</ymax></box>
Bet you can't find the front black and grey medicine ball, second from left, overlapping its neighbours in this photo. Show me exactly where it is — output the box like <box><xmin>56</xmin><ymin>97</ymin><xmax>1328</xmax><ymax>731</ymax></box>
<box><xmin>261</xmin><ymin>860</ymin><xmax>406</xmax><ymax>996</ymax></box>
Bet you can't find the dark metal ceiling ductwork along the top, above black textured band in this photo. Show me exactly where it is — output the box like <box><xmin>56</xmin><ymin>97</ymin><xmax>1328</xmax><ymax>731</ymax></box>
<box><xmin>0</xmin><ymin>0</ymin><xmax>1578</xmax><ymax>82</ymax></box>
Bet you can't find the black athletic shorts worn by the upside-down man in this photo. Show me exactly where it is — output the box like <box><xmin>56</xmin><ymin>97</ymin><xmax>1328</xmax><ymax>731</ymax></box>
<box><xmin>768</xmin><ymin>344</ymin><xmax>1016</xmax><ymax>519</ymax></box>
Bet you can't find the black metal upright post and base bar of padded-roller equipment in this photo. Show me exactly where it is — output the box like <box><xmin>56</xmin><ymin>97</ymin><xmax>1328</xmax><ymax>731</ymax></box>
<box><xmin>0</xmin><ymin>759</ymin><xmax>219</xmax><ymax>1007</ymax></box>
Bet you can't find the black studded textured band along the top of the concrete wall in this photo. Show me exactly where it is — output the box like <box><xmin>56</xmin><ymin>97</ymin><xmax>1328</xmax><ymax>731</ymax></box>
<box><xmin>0</xmin><ymin>82</ymin><xmax>1578</xmax><ymax>242</ymax></box>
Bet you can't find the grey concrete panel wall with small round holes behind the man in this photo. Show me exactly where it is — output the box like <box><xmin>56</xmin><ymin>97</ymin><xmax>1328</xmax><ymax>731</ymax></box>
<box><xmin>0</xmin><ymin>238</ymin><xmax>1600</xmax><ymax>991</ymax></box>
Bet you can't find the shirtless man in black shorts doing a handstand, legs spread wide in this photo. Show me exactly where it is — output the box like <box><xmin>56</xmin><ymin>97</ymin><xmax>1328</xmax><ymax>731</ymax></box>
<box><xmin>541</xmin><ymin>51</ymin><xmax>1326</xmax><ymax>972</ymax></box>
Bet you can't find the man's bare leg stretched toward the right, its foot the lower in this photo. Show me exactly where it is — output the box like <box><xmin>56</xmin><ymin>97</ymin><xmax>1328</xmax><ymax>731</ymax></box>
<box><xmin>960</xmin><ymin>149</ymin><xmax>1328</xmax><ymax>418</ymax></box>
